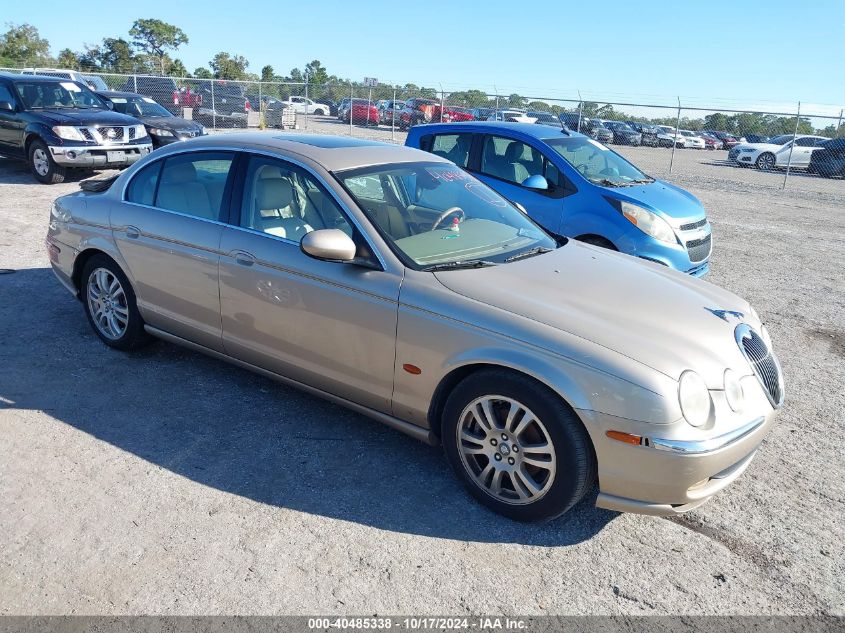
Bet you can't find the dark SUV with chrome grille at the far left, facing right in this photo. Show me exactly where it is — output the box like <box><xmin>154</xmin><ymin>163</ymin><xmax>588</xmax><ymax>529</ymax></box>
<box><xmin>0</xmin><ymin>73</ymin><xmax>152</xmax><ymax>184</ymax></box>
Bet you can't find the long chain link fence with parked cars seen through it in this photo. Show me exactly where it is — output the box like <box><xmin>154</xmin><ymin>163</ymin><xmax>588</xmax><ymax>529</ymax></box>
<box><xmin>0</xmin><ymin>68</ymin><xmax>845</xmax><ymax>186</ymax></box>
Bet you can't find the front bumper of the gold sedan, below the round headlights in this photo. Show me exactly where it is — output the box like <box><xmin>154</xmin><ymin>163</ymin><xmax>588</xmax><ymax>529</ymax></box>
<box><xmin>578</xmin><ymin>408</ymin><xmax>776</xmax><ymax>516</ymax></box>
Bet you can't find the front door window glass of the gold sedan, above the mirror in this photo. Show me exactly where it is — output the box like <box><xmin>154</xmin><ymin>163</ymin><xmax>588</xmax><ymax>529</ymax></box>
<box><xmin>240</xmin><ymin>156</ymin><xmax>353</xmax><ymax>242</ymax></box>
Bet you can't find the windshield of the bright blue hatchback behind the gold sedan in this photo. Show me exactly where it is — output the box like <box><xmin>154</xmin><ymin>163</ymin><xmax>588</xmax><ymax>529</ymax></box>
<box><xmin>545</xmin><ymin>136</ymin><xmax>653</xmax><ymax>187</ymax></box>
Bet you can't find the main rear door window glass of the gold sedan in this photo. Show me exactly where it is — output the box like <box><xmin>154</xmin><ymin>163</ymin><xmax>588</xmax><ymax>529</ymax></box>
<box><xmin>153</xmin><ymin>152</ymin><xmax>234</xmax><ymax>220</ymax></box>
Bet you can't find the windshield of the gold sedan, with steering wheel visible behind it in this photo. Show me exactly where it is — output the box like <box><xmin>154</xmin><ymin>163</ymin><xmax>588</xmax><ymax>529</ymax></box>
<box><xmin>337</xmin><ymin>163</ymin><xmax>557</xmax><ymax>269</ymax></box>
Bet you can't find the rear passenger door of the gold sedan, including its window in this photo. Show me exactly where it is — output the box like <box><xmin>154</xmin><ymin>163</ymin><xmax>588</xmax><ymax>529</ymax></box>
<box><xmin>111</xmin><ymin>151</ymin><xmax>235</xmax><ymax>351</ymax></box>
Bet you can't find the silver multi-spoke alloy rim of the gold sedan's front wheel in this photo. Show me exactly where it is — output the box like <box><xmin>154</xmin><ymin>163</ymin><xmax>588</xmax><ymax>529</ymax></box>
<box><xmin>456</xmin><ymin>395</ymin><xmax>557</xmax><ymax>505</ymax></box>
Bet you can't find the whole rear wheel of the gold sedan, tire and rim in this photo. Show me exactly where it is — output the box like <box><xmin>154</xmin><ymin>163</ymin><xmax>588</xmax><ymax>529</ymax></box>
<box><xmin>81</xmin><ymin>255</ymin><xmax>151</xmax><ymax>351</ymax></box>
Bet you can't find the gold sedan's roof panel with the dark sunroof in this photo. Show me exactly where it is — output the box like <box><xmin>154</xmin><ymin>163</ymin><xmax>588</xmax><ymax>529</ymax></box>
<box><xmin>159</xmin><ymin>132</ymin><xmax>449</xmax><ymax>171</ymax></box>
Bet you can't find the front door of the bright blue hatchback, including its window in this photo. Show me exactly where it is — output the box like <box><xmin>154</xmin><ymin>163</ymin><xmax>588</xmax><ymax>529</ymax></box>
<box><xmin>470</xmin><ymin>134</ymin><xmax>565</xmax><ymax>234</ymax></box>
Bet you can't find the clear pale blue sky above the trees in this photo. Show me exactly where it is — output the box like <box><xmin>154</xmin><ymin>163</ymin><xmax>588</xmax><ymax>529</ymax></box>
<box><xmin>6</xmin><ymin>0</ymin><xmax>845</xmax><ymax>116</ymax></box>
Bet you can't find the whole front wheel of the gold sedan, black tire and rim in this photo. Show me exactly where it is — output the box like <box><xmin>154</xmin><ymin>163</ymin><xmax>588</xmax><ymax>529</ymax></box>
<box><xmin>441</xmin><ymin>369</ymin><xmax>596</xmax><ymax>521</ymax></box>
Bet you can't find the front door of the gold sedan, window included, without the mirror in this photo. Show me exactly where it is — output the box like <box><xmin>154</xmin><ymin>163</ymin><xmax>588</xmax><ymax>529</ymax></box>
<box><xmin>220</xmin><ymin>155</ymin><xmax>401</xmax><ymax>412</ymax></box>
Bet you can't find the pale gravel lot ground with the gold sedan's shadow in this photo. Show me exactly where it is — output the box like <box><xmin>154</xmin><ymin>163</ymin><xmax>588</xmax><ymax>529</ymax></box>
<box><xmin>0</xmin><ymin>126</ymin><xmax>845</xmax><ymax>614</ymax></box>
